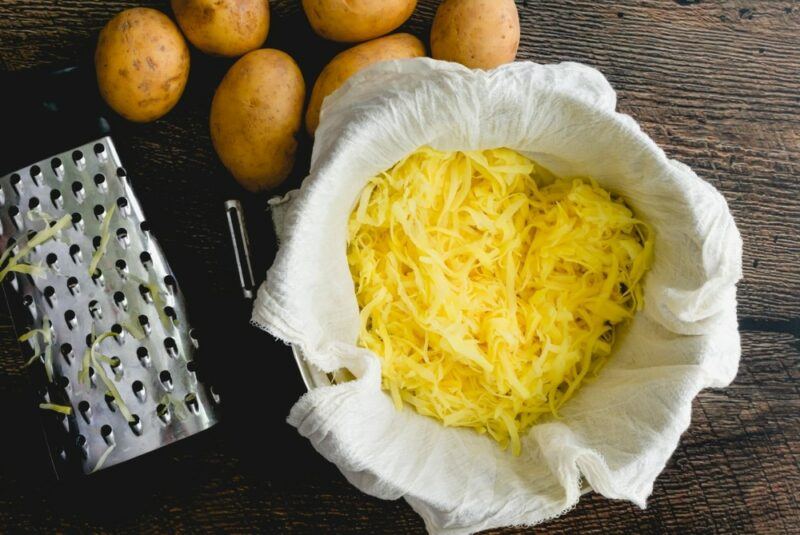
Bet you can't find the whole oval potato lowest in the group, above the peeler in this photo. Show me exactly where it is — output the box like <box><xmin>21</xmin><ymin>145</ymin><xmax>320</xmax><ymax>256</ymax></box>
<box><xmin>210</xmin><ymin>48</ymin><xmax>306</xmax><ymax>191</ymax></box>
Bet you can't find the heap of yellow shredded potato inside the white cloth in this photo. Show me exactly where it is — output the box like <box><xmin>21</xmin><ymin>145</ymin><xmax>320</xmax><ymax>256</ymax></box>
<box><xmin>347</xmin><ymin>148</ymin><xmax>653</xmax><ymax>454</ymax></box>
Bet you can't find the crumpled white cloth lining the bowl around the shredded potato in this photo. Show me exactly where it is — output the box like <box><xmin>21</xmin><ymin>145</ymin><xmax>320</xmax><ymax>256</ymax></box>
<box><xmin>253</xmin><ymin>59</ymin><xmax>742</xmax><ymax>534</ymax></box>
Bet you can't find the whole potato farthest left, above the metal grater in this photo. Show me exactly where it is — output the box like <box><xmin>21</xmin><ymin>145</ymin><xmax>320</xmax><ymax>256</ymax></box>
<box><xmin>94</xmin><ymin>7</ymin><xmax>189</xmax><ymax>123</ymax></box>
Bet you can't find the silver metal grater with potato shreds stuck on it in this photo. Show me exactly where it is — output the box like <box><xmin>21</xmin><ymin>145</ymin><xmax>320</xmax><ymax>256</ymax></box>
<box><xmin>0</xmin><ymin>137</ymin><xmax>219</xmax><ymax>477</ymax></box>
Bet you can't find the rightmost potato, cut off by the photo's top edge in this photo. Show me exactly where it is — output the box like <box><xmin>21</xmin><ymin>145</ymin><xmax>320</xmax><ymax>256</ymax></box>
<box><xmin>431</xmin><ymin>0</ymin><xmax>519</xmax><ymax>69</ymax></box>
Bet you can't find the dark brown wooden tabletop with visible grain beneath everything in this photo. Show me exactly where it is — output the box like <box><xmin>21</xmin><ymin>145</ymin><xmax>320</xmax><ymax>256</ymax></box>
<box><xmin>0</xmin><ymin>0</ymin><xmax>800</xmax><ymax>533</ymax></box>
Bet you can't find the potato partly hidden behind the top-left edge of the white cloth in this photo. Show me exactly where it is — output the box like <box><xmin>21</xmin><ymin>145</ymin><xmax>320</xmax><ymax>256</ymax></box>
<box><xmin>306</xmin><ymin>33</ymin><xmax>425</xmax><ymax>136</ymax></box>
